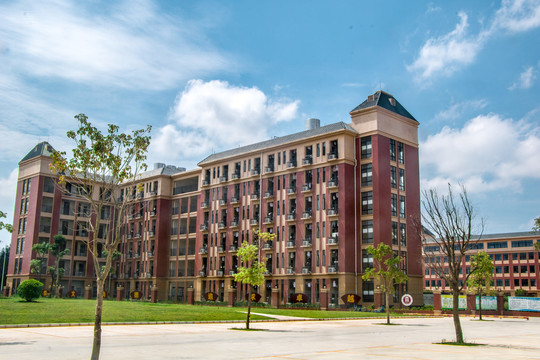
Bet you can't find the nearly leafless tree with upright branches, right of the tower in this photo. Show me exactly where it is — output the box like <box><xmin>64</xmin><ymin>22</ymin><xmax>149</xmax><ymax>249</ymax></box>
<box><xmin>419</xmin><ymin>184</ymin><xmax>484</xmax><ymax>344</ymax></box>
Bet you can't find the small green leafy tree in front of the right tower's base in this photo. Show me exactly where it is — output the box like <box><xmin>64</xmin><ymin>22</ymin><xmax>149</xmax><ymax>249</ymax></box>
<box><xmin>362</xmin><ymin>243</ymin><xmax>409</xmax><ymax>324</ymax></box>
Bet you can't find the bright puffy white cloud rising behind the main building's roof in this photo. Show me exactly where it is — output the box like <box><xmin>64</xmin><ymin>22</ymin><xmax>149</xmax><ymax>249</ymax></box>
<box><xmin>151</xmin><ymin>80</ymin><xmax>299</xmax><ymax>165</ymax></box>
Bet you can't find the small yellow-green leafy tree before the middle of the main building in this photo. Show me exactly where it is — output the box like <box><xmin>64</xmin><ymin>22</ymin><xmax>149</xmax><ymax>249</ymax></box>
<box><xmin>234</xmin><ymin>232</ymin><xmax>275</xmax><ymax>330</ymax></box>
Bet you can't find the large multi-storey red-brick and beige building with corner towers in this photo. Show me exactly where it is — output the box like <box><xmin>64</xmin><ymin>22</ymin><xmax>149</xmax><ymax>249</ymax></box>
<box><xmin>8</xmin><ymin>91</ymin><xmax>422</xmax><ymax>306</ymax></box>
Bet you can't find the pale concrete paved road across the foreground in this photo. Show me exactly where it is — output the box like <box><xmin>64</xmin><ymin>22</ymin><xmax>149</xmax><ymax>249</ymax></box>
<box><xmin>0</xmin><ymin>318</ymin><xmax>540</xmax><ymax>360</ymax></box>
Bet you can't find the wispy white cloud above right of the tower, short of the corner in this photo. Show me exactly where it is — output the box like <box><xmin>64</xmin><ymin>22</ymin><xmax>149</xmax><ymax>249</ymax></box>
<box><xmin>407</xmin><ymin>12</ymin><xmax>484</xmax><ymax>79</ymax></box>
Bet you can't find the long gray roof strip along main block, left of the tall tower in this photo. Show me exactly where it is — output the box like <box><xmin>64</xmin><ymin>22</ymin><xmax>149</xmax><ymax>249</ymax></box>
<box><xmin>198</xmin><ymin>122</ymin><xmax>357</xmax><ymax>166</ymax></box>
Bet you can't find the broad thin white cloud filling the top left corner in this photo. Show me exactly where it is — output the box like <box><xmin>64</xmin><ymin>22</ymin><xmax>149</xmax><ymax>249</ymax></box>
<box><xmin>0</xmin><ymin>0</ymin><xmax>232</xmax><ymax>90</ymax></box>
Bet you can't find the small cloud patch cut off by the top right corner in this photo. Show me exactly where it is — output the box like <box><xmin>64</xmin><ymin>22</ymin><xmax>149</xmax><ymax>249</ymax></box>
<box><xmin>493</xmin><ymin>0</ymin><xmax>540</xmax><ymax>32</ymax></box>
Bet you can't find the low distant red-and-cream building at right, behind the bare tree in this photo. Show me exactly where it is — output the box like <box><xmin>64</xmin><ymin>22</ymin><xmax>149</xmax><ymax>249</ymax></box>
<box><xmin>424</xmin><ymin>232</ymin><xmax>540</xmax><ymax>297</ymax></box>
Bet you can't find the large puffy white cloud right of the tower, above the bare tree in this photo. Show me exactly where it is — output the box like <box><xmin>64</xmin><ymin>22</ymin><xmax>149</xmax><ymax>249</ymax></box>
<box><xmin>420</xmin><ymin>114</ymin><xmax>540</xmax><ymax>192</ymax></box>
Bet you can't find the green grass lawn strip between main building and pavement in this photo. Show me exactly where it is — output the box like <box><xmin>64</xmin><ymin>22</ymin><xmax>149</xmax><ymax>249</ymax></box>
<box><xmin>0</xmin><ymin>296</ymin><xmax>396</xmax><ymax>325</ymax></box>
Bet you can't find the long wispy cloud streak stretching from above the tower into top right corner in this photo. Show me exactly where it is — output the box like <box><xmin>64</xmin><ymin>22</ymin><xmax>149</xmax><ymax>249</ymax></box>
<box><xmin>407</xmin><ymin>0</ymin><xmax>540</xmax><ymax>82</ymax></box>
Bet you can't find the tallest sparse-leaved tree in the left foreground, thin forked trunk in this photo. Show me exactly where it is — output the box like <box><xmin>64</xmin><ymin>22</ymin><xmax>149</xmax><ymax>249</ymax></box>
<box><xmin>51</xmin><ymin>114</ymin><xmax>151</xmax><ymax>359</ymax></box>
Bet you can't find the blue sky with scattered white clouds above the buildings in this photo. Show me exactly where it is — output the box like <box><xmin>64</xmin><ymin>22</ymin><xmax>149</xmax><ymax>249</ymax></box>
<box><xmin>0</xmin><ymin>0</ymin><xmax>540</xmax><ymax>245</ymax></box>
